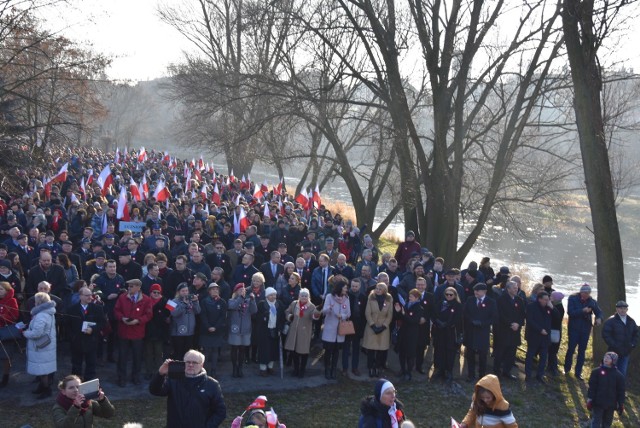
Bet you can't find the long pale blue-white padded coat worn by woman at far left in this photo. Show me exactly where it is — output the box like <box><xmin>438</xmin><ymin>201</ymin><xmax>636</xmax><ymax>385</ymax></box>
<box><xmin>23</xmin><ymin>302</ymin><xmax>58</xmax><ymax>376</ymax></box>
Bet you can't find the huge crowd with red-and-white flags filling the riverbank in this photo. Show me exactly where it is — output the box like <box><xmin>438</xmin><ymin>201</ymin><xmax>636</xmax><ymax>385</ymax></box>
<box><xmin>0</xmin><ymin>149</ymin><xmax>638</xmax><ymax>426</ymax></box>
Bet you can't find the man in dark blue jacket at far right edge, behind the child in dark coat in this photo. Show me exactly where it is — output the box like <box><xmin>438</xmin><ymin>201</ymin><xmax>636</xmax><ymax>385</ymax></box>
<box><xmin>602</xmin><ymin>300</ymin><xmax>640</xmax><ymax>376</ymax></box>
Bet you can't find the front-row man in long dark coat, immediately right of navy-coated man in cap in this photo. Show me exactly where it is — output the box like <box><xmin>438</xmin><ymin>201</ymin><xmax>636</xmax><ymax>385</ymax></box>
<box><xmin>493</xmin><ymin>281</ymin><xmax>526</xmax><ymax>380</ymax></box>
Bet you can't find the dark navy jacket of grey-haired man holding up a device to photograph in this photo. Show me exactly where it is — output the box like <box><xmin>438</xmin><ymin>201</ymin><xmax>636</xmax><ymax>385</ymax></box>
<box><xmin>149</xmin><ymin>370</ymin><xmax>227</xmax><ymax>428</ymax></box>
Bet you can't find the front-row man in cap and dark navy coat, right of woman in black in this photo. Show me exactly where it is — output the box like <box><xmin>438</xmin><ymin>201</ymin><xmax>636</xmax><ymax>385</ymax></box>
<box><xmin>463</xmin><ymin>282</ymin><xmax>498</xmax><ymax>382</ymax></box>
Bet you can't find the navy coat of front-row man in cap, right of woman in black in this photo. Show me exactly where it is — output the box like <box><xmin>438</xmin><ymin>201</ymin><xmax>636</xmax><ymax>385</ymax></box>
<box><xmin>463</xmin><ymin>296</ymin><xmax>498</xmax><ymax>352</ymax></box>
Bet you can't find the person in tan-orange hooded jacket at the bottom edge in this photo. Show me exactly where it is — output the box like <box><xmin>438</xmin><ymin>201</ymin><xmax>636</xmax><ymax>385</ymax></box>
<box><xmin>460</xmin><ymin>375</ymin><xmax>518</xmax><ymax>428</ymax></box>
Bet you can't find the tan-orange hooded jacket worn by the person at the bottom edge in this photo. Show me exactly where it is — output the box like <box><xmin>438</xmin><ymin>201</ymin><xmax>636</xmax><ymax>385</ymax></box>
<box><xmin>462</xmin><ymin>375</ymin><xmax>518</xmax><ymax>428</ymax></box>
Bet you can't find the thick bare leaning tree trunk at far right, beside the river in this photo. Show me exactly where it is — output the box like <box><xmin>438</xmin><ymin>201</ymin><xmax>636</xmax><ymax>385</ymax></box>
<box><xmin>562</xmin><ymin>0</ymin><xmax>625</xmax><ymax>361</ymax></box>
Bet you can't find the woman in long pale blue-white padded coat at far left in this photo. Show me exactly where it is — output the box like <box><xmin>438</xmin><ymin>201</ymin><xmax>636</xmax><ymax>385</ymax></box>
<box><xmin>22</xmin><ymin>292</ymin><xmax>57</xmax><ymax>399</ymax></box>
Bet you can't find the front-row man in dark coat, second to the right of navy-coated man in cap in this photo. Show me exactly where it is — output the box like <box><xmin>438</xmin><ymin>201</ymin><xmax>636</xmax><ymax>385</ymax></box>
<box><xmin>524</xmin><ymin>291</ymin><xmax>558</xmax><ymax>383</ymax></box>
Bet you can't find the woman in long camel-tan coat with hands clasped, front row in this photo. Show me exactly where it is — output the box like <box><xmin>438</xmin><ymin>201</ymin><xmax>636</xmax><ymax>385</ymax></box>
<box><xmin>362</xmin><ymin>282</ymin><xmax>393</xmax><ymax>377</ymax></box>
